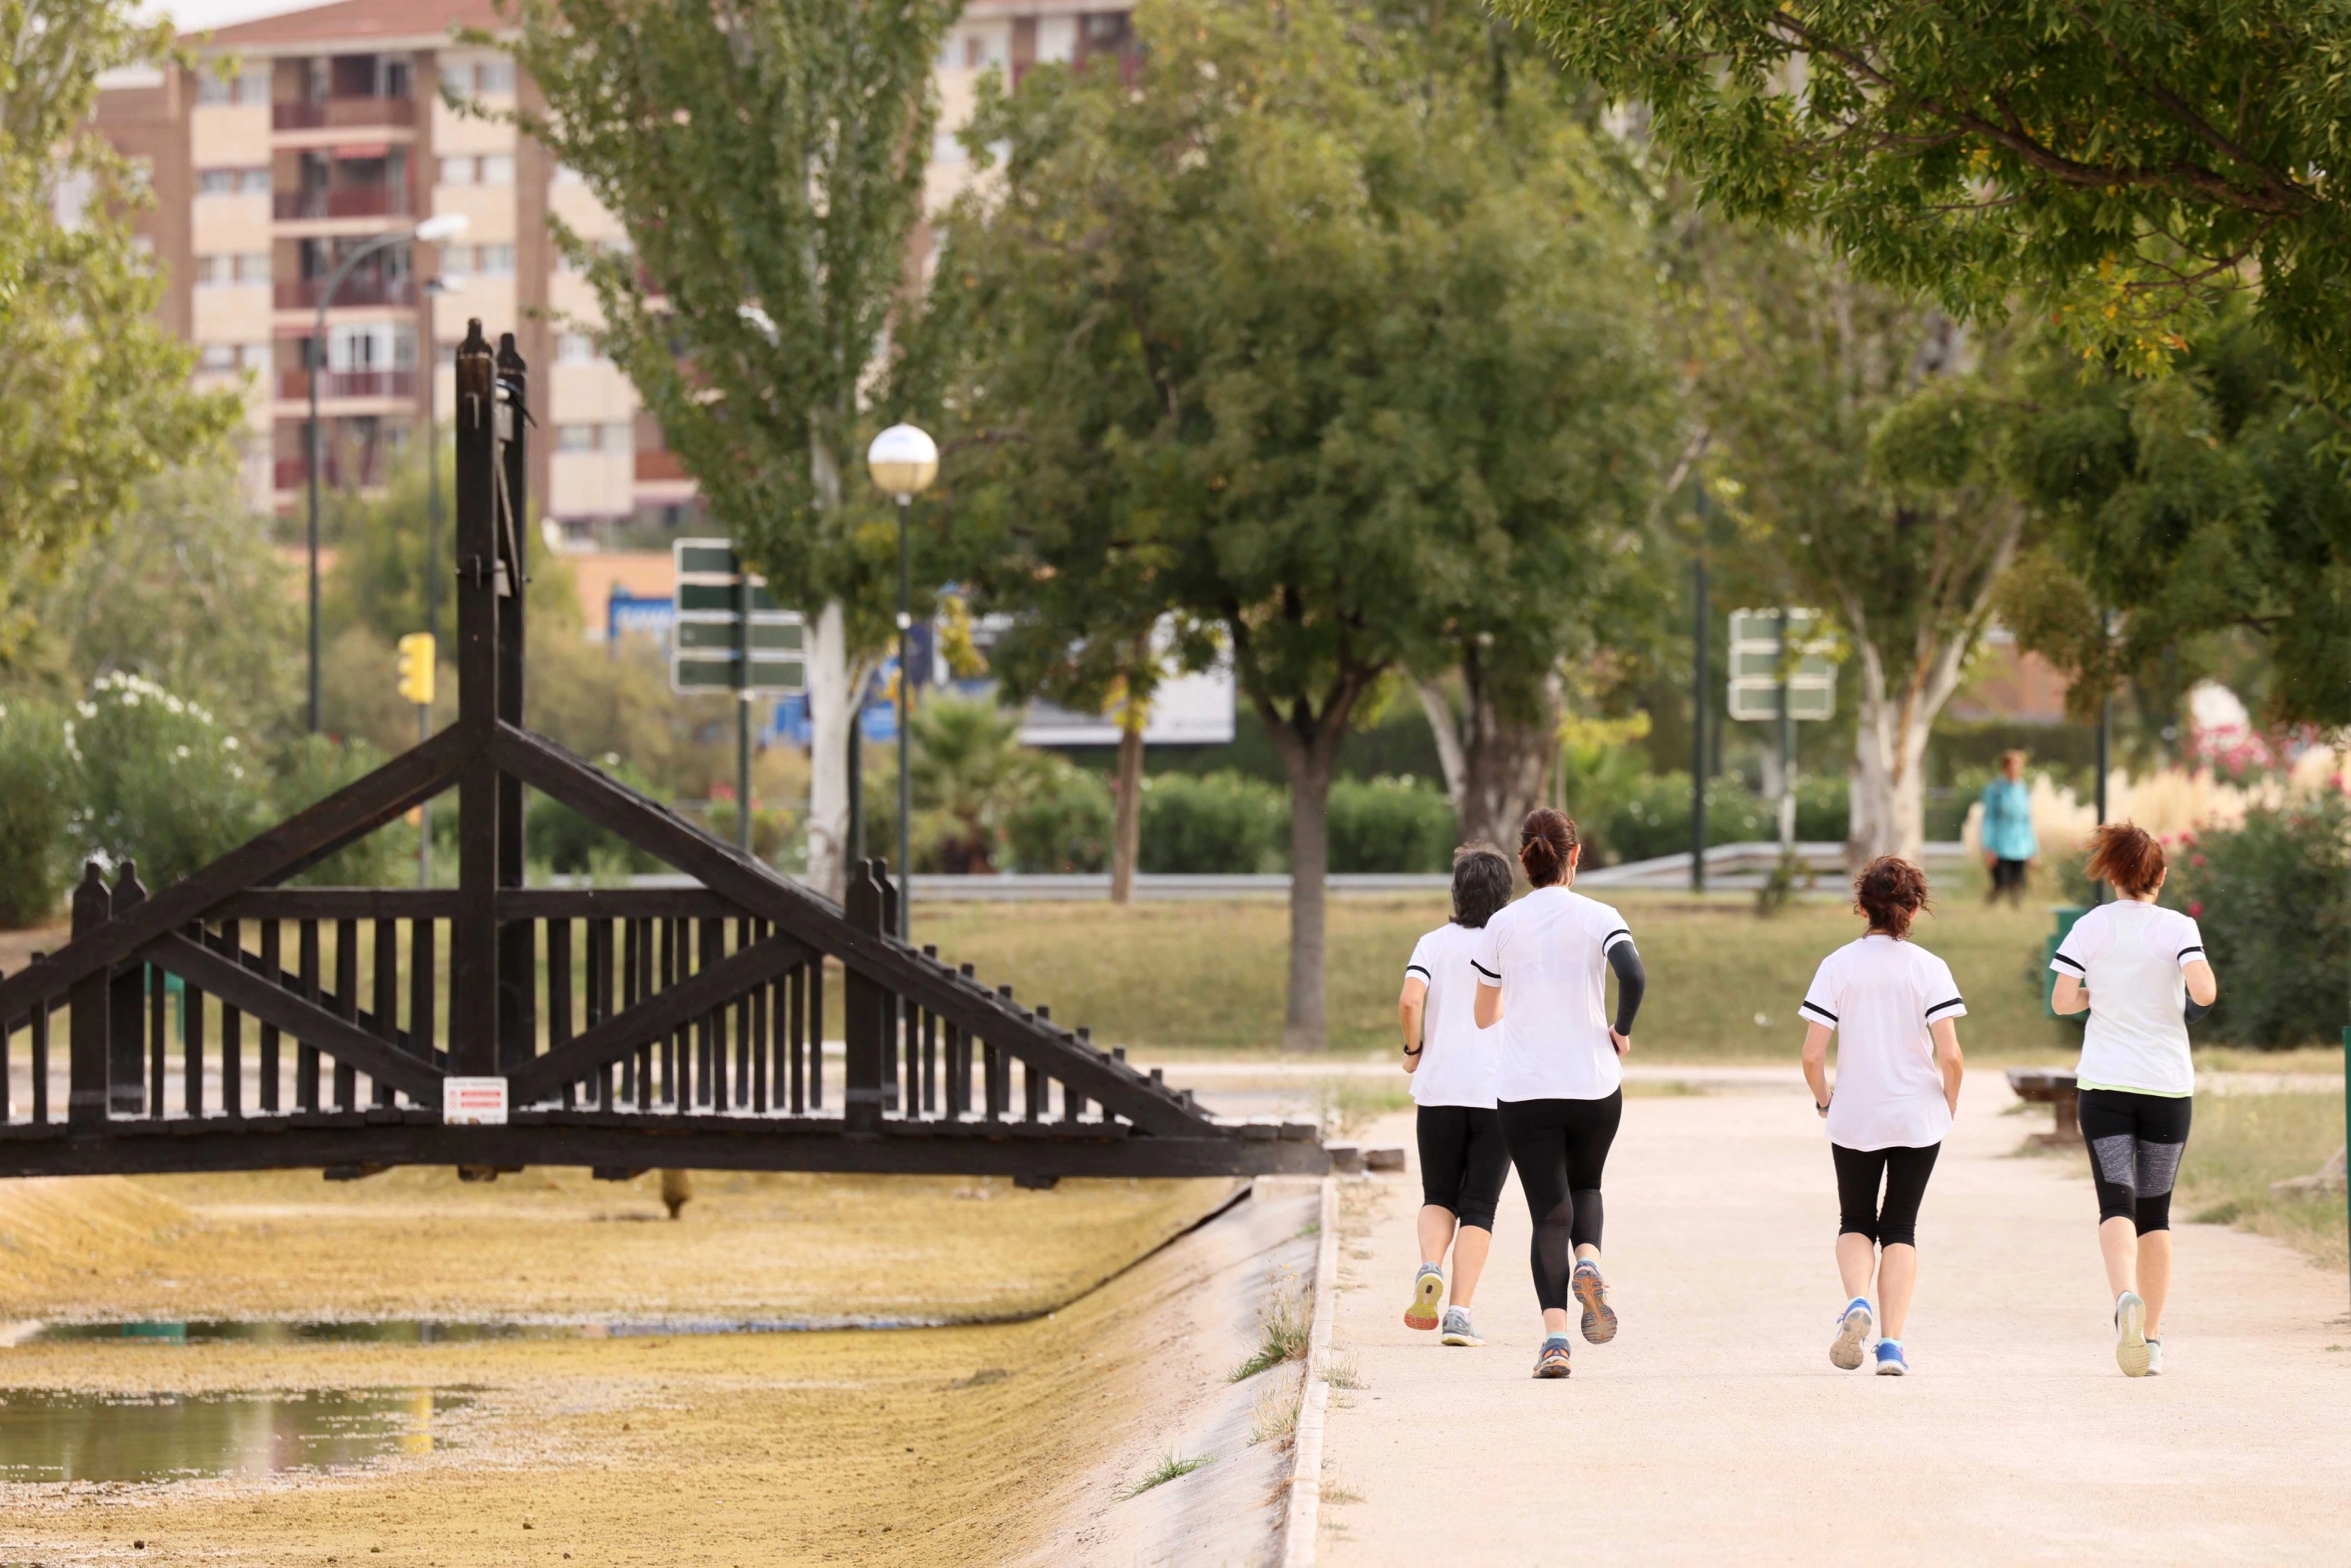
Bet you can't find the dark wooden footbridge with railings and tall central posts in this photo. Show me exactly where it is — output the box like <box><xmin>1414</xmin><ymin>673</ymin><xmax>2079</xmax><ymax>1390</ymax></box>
<box><xmin>0</xmin><ymin>322</ymin><xmax>1326</xmax><ymax>1182</ymax></box>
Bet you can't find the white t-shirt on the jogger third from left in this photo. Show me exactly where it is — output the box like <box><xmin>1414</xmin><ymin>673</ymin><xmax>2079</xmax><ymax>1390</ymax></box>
<box><xmin>1796</xmin><ymin>933</ymin><xmax>1968</xmax><ymax>1149</ymax></box>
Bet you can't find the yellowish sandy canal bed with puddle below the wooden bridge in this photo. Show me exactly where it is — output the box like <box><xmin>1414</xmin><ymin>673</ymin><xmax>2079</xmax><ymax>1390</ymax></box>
<box><xmin>0</xmin><ymin>1171</ymin><xmax>1295</xmax><ymax>1563</ymax></box>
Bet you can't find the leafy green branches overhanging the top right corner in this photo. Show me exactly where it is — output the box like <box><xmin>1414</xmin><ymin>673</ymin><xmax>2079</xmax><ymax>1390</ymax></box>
<box><xmin>1505</xmin><ymin>0</ymin><xmax>2351</xmax><ymax>407</ymax></box>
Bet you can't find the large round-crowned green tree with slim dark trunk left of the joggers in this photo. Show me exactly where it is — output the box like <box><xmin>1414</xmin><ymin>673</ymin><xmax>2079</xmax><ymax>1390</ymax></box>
<box><xmin>917</xmin><ymin>0</ymin><xmax>1651</xmax><ymax>1046</ymax></box>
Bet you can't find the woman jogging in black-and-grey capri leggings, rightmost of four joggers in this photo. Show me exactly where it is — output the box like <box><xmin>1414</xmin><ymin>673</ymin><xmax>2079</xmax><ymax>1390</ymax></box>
<box><xmin>2050</xmin><ymin>822</ymin><xmax>2219</xmax><ymax>1377</ymax></box>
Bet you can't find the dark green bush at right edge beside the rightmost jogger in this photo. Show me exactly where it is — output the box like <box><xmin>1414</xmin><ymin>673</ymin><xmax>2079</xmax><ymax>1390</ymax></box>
<box><xmin>2163</xmin><ymin>789</ymin><xmax>2351</xmax><ymax>1046</ymax></box>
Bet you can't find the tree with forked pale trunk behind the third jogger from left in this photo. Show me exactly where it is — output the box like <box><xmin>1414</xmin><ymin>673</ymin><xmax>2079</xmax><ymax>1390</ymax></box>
<box><xmin>1700</xmin><ymin>235</ymin><xmax>2026</xmax><ymax>860</ymax></box>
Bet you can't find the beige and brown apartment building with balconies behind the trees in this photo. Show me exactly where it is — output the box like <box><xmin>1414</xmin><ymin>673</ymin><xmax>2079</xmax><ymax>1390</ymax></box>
<box><xmin>99</xmin><ymin>0</ymin><xmax>1133</xmax><ymax>543</ymax></box>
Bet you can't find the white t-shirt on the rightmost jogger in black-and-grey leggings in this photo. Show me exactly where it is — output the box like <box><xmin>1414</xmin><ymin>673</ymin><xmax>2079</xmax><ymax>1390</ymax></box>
<box><xmin>2050</xmin><ymin>898</ymin><xmax>2205</xmax><ymax>1095</ymax></box>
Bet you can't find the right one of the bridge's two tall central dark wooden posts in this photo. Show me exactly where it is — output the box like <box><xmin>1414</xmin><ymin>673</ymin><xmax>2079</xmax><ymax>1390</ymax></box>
<box><xmin>496</xmin><ymin>332</ymin><xmax>539</xmax><ymax>1072</ymax></box>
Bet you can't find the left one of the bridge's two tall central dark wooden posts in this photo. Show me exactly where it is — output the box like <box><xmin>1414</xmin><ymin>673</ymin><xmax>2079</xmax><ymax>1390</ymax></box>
<box><xmin>449</xmin><ymin>320</ymin><xmax>501</xmax><ymax>1076</ymax></box>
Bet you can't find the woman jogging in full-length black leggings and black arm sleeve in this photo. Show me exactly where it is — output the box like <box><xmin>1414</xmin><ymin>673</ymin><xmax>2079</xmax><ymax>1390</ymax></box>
<box><xmin>1474</xmin><ymin>806</ymin><xmax>1648</xmax><ymax>1377</ymax></box>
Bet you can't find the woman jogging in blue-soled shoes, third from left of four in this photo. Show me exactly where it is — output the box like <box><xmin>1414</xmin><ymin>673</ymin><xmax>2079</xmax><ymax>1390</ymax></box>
<box><xmin>1796</xmin><ymin>855</ymin><xmax>1968</xmax><ymax>1377</ymax></box>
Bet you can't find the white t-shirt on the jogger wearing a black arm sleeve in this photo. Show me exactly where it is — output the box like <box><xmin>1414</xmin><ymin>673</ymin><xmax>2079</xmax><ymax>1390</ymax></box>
<box><xmin>1472</xmin><ymin>886</ymin><xmax>1632</xmax><ymax>1100</ymax></box>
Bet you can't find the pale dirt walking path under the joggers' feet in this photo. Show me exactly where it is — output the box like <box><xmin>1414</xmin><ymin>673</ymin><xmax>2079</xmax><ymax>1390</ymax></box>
<box><xmin>1321</xmin><ymin>1074</ymin><xmax>2351</xmax><ymax>1566</ymax></box>
